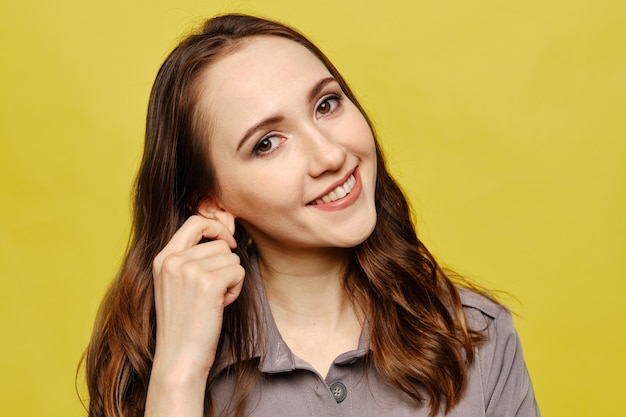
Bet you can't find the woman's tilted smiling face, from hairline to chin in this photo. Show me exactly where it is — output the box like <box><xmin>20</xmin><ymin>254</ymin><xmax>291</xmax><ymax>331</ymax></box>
<box><xmin>199</xmin><ymin>36</ymin><xmax>376</xmax><ymax>253</ymax></box>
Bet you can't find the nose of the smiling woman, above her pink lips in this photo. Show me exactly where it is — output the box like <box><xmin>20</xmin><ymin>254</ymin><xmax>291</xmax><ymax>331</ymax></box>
<box><xmin>306</xmin><ymin>127</ymin><xmax>347</xmax><ymax>177</ymax></box>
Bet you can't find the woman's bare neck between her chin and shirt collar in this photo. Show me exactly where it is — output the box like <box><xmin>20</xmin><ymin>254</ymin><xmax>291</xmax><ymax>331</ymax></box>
<box><xmin>254</xmin><ymin>245</ymin><xmax>362</xmax><ymax>376</ymax></box>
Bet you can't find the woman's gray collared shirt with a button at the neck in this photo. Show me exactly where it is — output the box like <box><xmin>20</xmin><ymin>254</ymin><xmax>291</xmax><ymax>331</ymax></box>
<box><xmin>211</xmin><ymin>262</ymin><xmax>540</xmax><ymax>417</ymax></box>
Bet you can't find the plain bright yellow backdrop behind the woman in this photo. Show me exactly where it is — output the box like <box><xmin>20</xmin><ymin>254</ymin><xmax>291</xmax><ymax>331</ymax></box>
<box><xmin>0</xmin><ymin>0</ymin><xmax>626</xmax><ymax>417</ymax></box>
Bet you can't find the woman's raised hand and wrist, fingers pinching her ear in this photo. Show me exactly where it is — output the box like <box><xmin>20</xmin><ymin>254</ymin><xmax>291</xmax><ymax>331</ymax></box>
<box><xmin>146</xmin><ymin>216</ymin><xmax>245</xmax><ymax>416</ymax></box>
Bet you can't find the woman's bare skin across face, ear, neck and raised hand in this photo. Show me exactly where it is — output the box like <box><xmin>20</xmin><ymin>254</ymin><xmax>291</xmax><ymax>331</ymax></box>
<box><xmin>145</xmin><ymin>36</ymin><xmax>376</xmax><ymax>417</ymax></box>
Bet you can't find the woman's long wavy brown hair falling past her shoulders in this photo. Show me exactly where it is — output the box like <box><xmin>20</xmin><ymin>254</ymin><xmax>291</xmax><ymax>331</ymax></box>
<box><xmin>85</xmin><ymin>15</ymin><xmax>482</xmax><ymax>417</ymax></box>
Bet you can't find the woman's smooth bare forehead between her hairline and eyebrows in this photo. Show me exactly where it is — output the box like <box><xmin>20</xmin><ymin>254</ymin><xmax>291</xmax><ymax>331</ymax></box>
<box><xmin>198</xmin><ymin>36</ymin><xmax>330</xmax><ymax>135</ymax></box>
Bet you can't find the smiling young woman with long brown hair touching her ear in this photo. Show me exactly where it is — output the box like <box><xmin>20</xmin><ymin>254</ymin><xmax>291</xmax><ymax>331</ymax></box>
<box><xmin>86</xmin><ymin>15</ymin><xmax>539</xmax><ymax>417</ymax></box>
